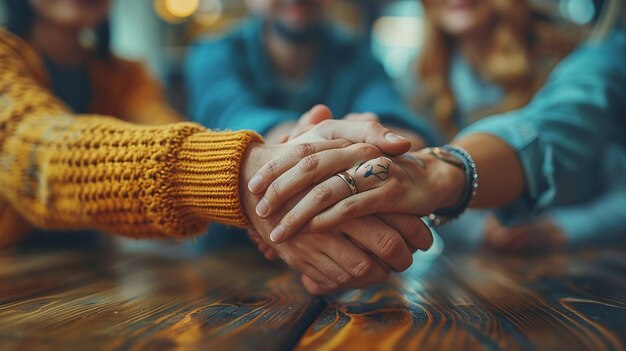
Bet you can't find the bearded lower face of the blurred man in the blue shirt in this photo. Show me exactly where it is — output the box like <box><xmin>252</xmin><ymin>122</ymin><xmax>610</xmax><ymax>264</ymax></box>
<box><xmin>246</xmin><ymin>0</ymin><xmax>330</xmax><ymax>32</ymax></box>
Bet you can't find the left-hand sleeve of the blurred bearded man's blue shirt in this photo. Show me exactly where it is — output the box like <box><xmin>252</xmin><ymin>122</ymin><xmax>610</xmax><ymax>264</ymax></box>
<box><xmin>184</xmin><ymin>39</ymin><xmax>299</xmax><ymax>134</ymax></box>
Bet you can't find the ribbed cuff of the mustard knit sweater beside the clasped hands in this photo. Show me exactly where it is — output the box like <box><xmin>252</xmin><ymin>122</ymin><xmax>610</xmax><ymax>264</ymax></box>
<box><xmin>175</xmin><ymin>131</ymin><xmax>263</xmax><ymax>227</ymax></box>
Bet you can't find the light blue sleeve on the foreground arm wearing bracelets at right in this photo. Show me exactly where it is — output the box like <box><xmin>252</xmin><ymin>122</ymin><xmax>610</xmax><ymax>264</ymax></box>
<box><xmin>460</xmin><ymin>32</ymin><xmax>626</xmax><ymax>225</ymax></box>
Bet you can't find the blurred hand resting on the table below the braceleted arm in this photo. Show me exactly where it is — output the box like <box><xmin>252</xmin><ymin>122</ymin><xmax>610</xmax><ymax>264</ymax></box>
<box><xmin>483</xmin><ymin>216</ymin><xmax>566</xmax><ymax>254</ymax></box>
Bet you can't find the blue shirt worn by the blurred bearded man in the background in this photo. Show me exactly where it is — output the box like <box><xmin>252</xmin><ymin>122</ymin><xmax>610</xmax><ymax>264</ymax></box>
<box><xmin>185</xmin><ymin>19</ymin><xmax>438</xmax><ymax>144</ymax></box>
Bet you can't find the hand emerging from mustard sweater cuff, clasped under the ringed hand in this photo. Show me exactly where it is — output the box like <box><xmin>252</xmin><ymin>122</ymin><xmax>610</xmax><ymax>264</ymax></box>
<box><xmin>240</xmin><ymin>142</ymin><xmax>432</xmax><ymax>294</ymax></box>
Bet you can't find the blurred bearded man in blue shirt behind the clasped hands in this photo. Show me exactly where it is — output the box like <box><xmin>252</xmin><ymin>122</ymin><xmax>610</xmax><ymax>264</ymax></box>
<box><xmin>186</xmin><ymin>0</ymin><xmax>437</xmax><ymax>149</ymax></box>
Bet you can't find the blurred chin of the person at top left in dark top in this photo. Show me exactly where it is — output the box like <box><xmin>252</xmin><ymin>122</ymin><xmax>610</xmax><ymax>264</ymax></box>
<box><xmin>25</xmin><ymin>0</ymin><xmax>111</xmax><ymax>29</ymax></box>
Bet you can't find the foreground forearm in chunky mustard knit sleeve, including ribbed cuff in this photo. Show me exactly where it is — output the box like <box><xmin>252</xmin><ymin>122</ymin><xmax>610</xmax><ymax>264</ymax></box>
<box><xmin>0</xmin><ymin>116</ymin><xmax>260</xmax><ymax>237</ymax></box>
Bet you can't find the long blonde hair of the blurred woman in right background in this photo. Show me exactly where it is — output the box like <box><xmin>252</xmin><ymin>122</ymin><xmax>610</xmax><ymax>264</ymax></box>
<box><xmin>416</xmin><ymin>0</ymin><xmax>578</xmax><ymax>138</ymax></box>
